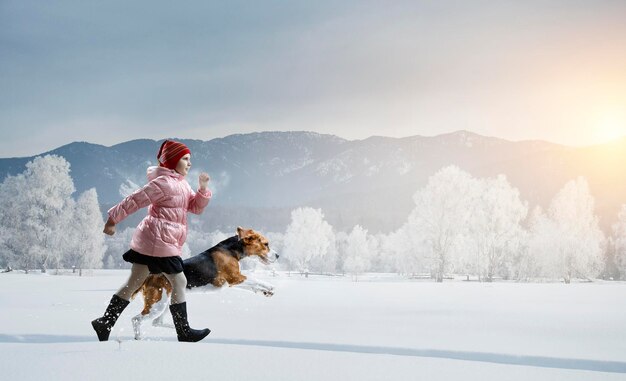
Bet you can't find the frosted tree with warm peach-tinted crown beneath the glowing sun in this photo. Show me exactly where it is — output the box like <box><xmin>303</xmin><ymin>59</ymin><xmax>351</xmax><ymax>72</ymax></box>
<box><xmin>548</xmin><ymin>177</ymin><xmax>604</xmax><ymax>283</ymax></box>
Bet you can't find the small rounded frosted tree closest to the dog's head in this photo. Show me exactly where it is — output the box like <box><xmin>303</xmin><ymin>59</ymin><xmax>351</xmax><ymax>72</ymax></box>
<box><xmin>283</xmin><ymin>208</ymin><xmax>335</xmax><ymax>272</ymax></box>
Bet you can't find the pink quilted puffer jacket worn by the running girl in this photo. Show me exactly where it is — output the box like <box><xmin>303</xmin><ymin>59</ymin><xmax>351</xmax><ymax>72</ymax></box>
<box><xmin>109</xmin><ymin>167</ymin><xmax>211</xmax><ymax>257</ymax></box>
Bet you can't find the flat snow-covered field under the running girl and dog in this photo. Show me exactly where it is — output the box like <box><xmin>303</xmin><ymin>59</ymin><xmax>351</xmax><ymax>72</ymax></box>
<box><xmin>0</xmin><ymin>270</ymin><xmax>626</xmax><ymax>381</ymax></box>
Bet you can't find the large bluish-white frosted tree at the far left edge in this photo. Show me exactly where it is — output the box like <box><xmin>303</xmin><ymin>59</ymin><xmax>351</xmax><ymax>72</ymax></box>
<box><xmin>0</xmin><ymin>155</ymin><xmax>74</xmax><ymax>272</ymax></box>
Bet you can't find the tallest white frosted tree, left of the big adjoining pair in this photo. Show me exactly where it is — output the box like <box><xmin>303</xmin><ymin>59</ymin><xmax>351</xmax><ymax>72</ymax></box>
<box><xmin>406</xmin><ymin>166</ymin><xmax>478</xmax><ymax>282</ymax></box>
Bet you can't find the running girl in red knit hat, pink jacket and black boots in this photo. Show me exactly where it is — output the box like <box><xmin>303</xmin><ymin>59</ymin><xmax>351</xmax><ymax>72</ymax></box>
<box><xmin>91</xmin><ymin>140</ymin><xmax>211</xmax><ymax>342</ymax></box>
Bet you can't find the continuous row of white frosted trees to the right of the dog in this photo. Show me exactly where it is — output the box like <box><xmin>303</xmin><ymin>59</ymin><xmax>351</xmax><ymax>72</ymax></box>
<box><xmin>272</xmin><ymin>166</ymin><xmax>626</xmax><ymax>283</ymax></box>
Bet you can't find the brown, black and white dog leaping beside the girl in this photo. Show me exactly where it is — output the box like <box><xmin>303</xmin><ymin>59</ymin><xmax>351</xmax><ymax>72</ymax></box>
<box><xmin>132</xmin><ymin>227</ymin><xmax>278</xmax><ymax>340</ymax></box>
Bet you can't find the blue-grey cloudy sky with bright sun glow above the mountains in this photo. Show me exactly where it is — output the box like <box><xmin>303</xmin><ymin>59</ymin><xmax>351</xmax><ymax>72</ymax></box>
<box><xmin>0</xmin><ymin>0</ymin><xmax>626</xmax><ymax>157</ymax></box>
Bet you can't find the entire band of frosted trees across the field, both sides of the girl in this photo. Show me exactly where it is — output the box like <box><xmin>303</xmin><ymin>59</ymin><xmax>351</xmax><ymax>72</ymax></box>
<box><xmin>0</xmin><ymin>155</ymin><xmax>626</xmax><ymax>283</ymax></box>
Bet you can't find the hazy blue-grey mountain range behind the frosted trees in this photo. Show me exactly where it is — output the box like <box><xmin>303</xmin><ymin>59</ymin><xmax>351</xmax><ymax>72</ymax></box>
<box><xmin>0</xmin><ymin>131</ymin><xmax>626</xmax><ymax>232</ymax></box>
